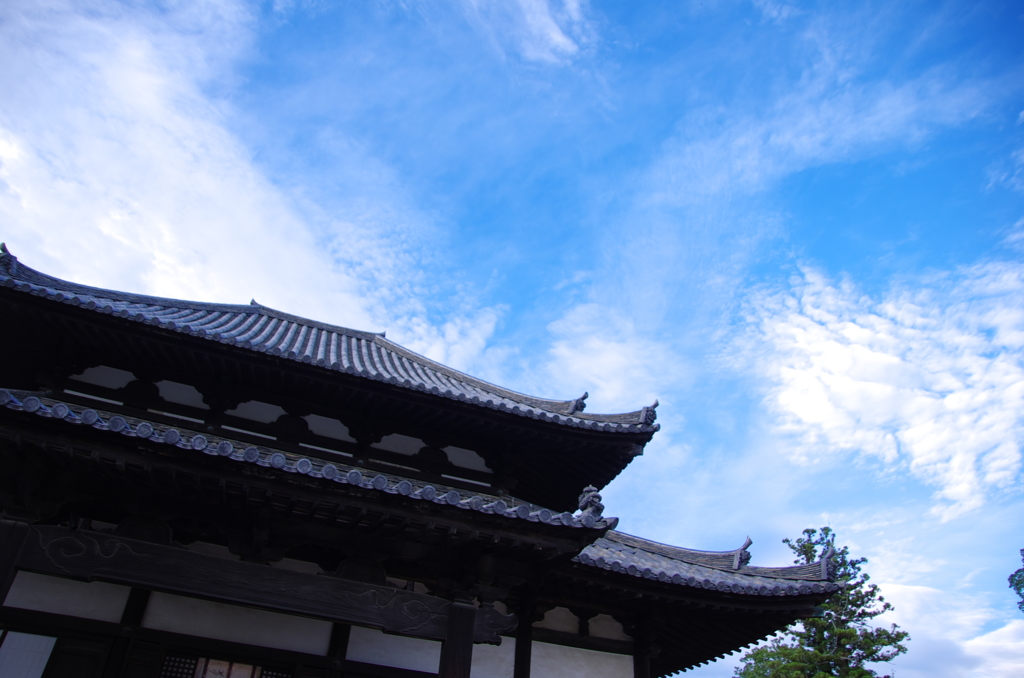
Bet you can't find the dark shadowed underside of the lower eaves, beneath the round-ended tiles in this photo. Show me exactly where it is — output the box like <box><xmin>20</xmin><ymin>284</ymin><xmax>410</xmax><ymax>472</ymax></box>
<box><xmin>0</xmin><ymin>413</ymin><xmax>827</xmax><ymax>676</ymax></box>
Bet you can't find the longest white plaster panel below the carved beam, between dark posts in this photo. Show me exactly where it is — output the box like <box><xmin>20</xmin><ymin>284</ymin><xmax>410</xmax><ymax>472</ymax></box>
<box><xmin>142</xmin><ymin>592</ymin><xmax>331</xmax><ymax>655</ymax></box>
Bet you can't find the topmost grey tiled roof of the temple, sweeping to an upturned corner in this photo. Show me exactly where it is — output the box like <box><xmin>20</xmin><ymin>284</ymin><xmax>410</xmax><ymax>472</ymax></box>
<box><xmin>0</xmin><ymin>247</ymin><xmax>659</xmax><ymax>433</ymax></box>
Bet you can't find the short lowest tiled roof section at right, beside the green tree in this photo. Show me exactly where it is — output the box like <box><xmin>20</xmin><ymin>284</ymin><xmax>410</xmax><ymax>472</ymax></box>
<box><xmin>575</xmin><ymin>531</ymin><xmax>843</xmax><ymax>596</ymax></box>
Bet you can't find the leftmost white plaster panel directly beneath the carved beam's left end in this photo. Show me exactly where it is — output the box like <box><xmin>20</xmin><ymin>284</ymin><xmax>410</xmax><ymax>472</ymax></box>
<box><xmin>0</xmin><ymin>571</ymin><xmax>131</xmax><ymax>622</ymax></box>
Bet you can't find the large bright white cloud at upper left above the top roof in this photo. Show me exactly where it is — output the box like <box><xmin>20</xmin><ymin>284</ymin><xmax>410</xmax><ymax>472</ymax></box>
<box><xmin>0</xmin><ymin>0</ymin><xmax>497</xmax><ymax>372</ymax></box>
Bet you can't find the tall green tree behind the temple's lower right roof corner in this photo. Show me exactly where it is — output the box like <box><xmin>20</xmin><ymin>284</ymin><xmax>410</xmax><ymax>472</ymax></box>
<box><xmin>735</xmin><ymin>527</ymin><xmax>909</xmax><ymax>678</ymax></box>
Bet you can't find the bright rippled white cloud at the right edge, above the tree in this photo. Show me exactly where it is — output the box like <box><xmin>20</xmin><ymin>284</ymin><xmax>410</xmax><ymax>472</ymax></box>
<box><xmin>746</xmin><ymin>263</ymin><xmax>1024</xmax><ymax>519</ymax></box>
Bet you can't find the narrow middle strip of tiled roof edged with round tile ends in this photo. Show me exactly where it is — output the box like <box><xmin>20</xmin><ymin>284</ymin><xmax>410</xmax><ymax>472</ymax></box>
<box><xmin>0</xmin><ymin>389</ymin><xmax>618</xmax><ymax>529</ymax></box>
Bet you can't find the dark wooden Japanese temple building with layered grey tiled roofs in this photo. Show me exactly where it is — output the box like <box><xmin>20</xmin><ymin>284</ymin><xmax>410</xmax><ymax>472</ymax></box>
<box><xmin>0</xmin><ymin>247</ymin><xmax>842</xmax><ymax>678</ymax></box>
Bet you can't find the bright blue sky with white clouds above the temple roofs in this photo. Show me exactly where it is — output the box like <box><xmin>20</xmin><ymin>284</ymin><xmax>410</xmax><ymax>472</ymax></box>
<box><xmin>0</xmin><ymin>0</ymin><xmax>1024</xmax><ymax>678</ymax></box>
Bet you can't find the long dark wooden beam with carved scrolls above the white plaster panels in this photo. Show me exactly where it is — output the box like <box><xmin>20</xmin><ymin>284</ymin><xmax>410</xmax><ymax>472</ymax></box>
<box><xmin>17</xmin><ymin>526</ymin><xmax>516</xmax><ymax>643</ymax></box>
